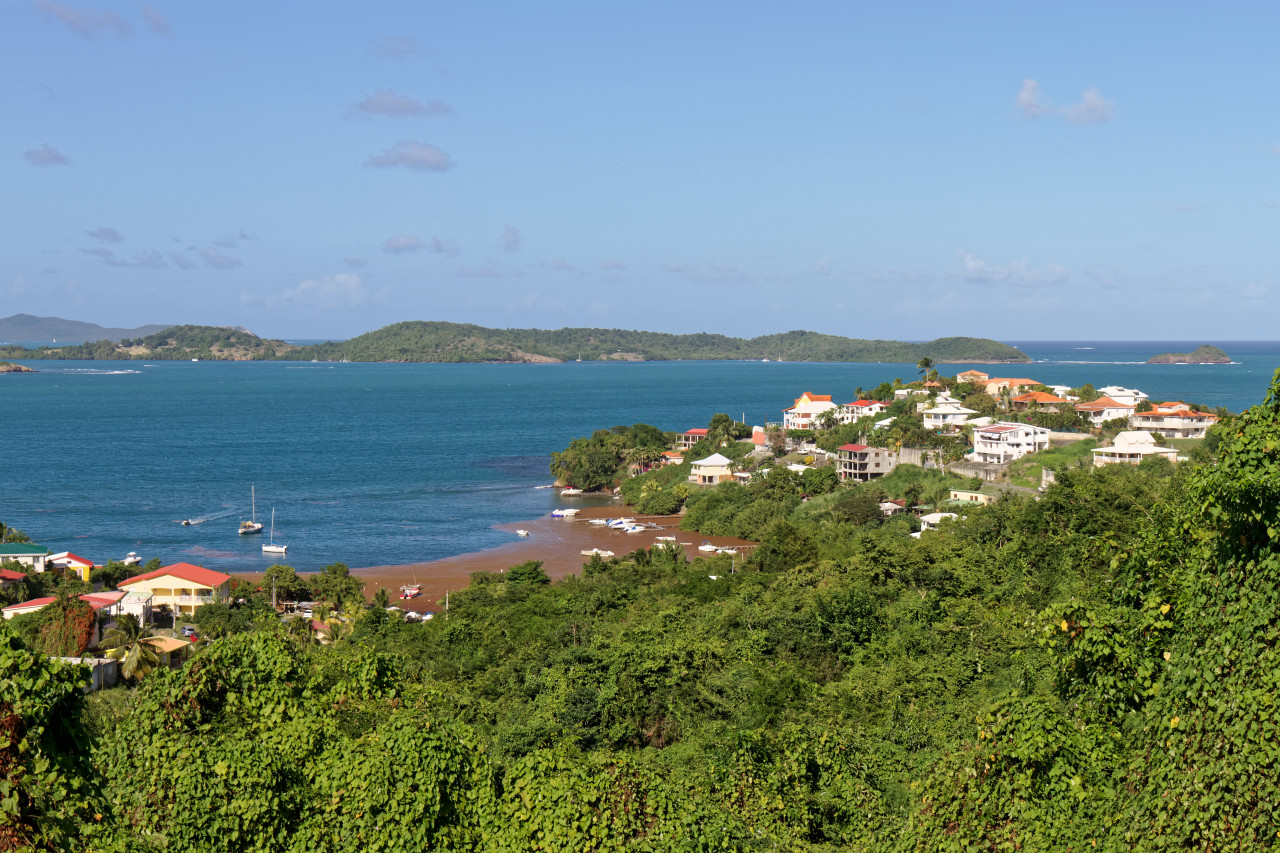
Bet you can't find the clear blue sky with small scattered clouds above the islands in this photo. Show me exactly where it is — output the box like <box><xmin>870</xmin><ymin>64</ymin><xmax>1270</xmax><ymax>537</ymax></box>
<box><xmin>0</xmin><ymin>0</ymin><xmax>1280</xmax><ymax>339</ymax></box>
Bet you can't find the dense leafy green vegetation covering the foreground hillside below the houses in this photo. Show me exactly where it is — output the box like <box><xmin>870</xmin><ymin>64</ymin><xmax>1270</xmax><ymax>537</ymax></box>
<box><xmin>0</xmin><ymin>371</ymin><xmax>1280</xmax><ymax>853</ymax></box>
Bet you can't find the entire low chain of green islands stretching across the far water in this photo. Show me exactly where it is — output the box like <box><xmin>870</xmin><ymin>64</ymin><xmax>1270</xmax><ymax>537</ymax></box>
<box><xmin>0</xmin><ymin>321</ymin><xmax>1030</xmax><ymax>364</ymax></box>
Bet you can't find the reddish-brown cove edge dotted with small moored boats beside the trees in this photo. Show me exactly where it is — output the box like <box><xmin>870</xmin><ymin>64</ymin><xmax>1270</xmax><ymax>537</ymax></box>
<box><xmin>241</xmin><ymin>505</ymin><xmax>755</xmax><ymax>611</ymax></box>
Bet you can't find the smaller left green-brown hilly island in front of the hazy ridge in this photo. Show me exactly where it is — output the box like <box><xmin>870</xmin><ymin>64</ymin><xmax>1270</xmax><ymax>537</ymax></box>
<box><xmin>0</xmin><ymin>325</ymin><xmax>298</xmax><ymax>361</ymax></box>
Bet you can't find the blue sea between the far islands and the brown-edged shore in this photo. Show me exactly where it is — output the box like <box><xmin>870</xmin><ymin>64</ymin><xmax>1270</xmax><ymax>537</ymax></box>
<box><xmin>0</xmin><ymin>342</ymin><xmax>1280</xmax><ymax>571</ymax></box>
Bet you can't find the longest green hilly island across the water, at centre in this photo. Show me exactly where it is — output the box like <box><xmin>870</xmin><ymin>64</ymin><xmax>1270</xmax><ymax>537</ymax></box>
<box><xmin>284</xmin><ymin>321</ymin><xmax>1030</xmax><ymax>364</ymax></box>
